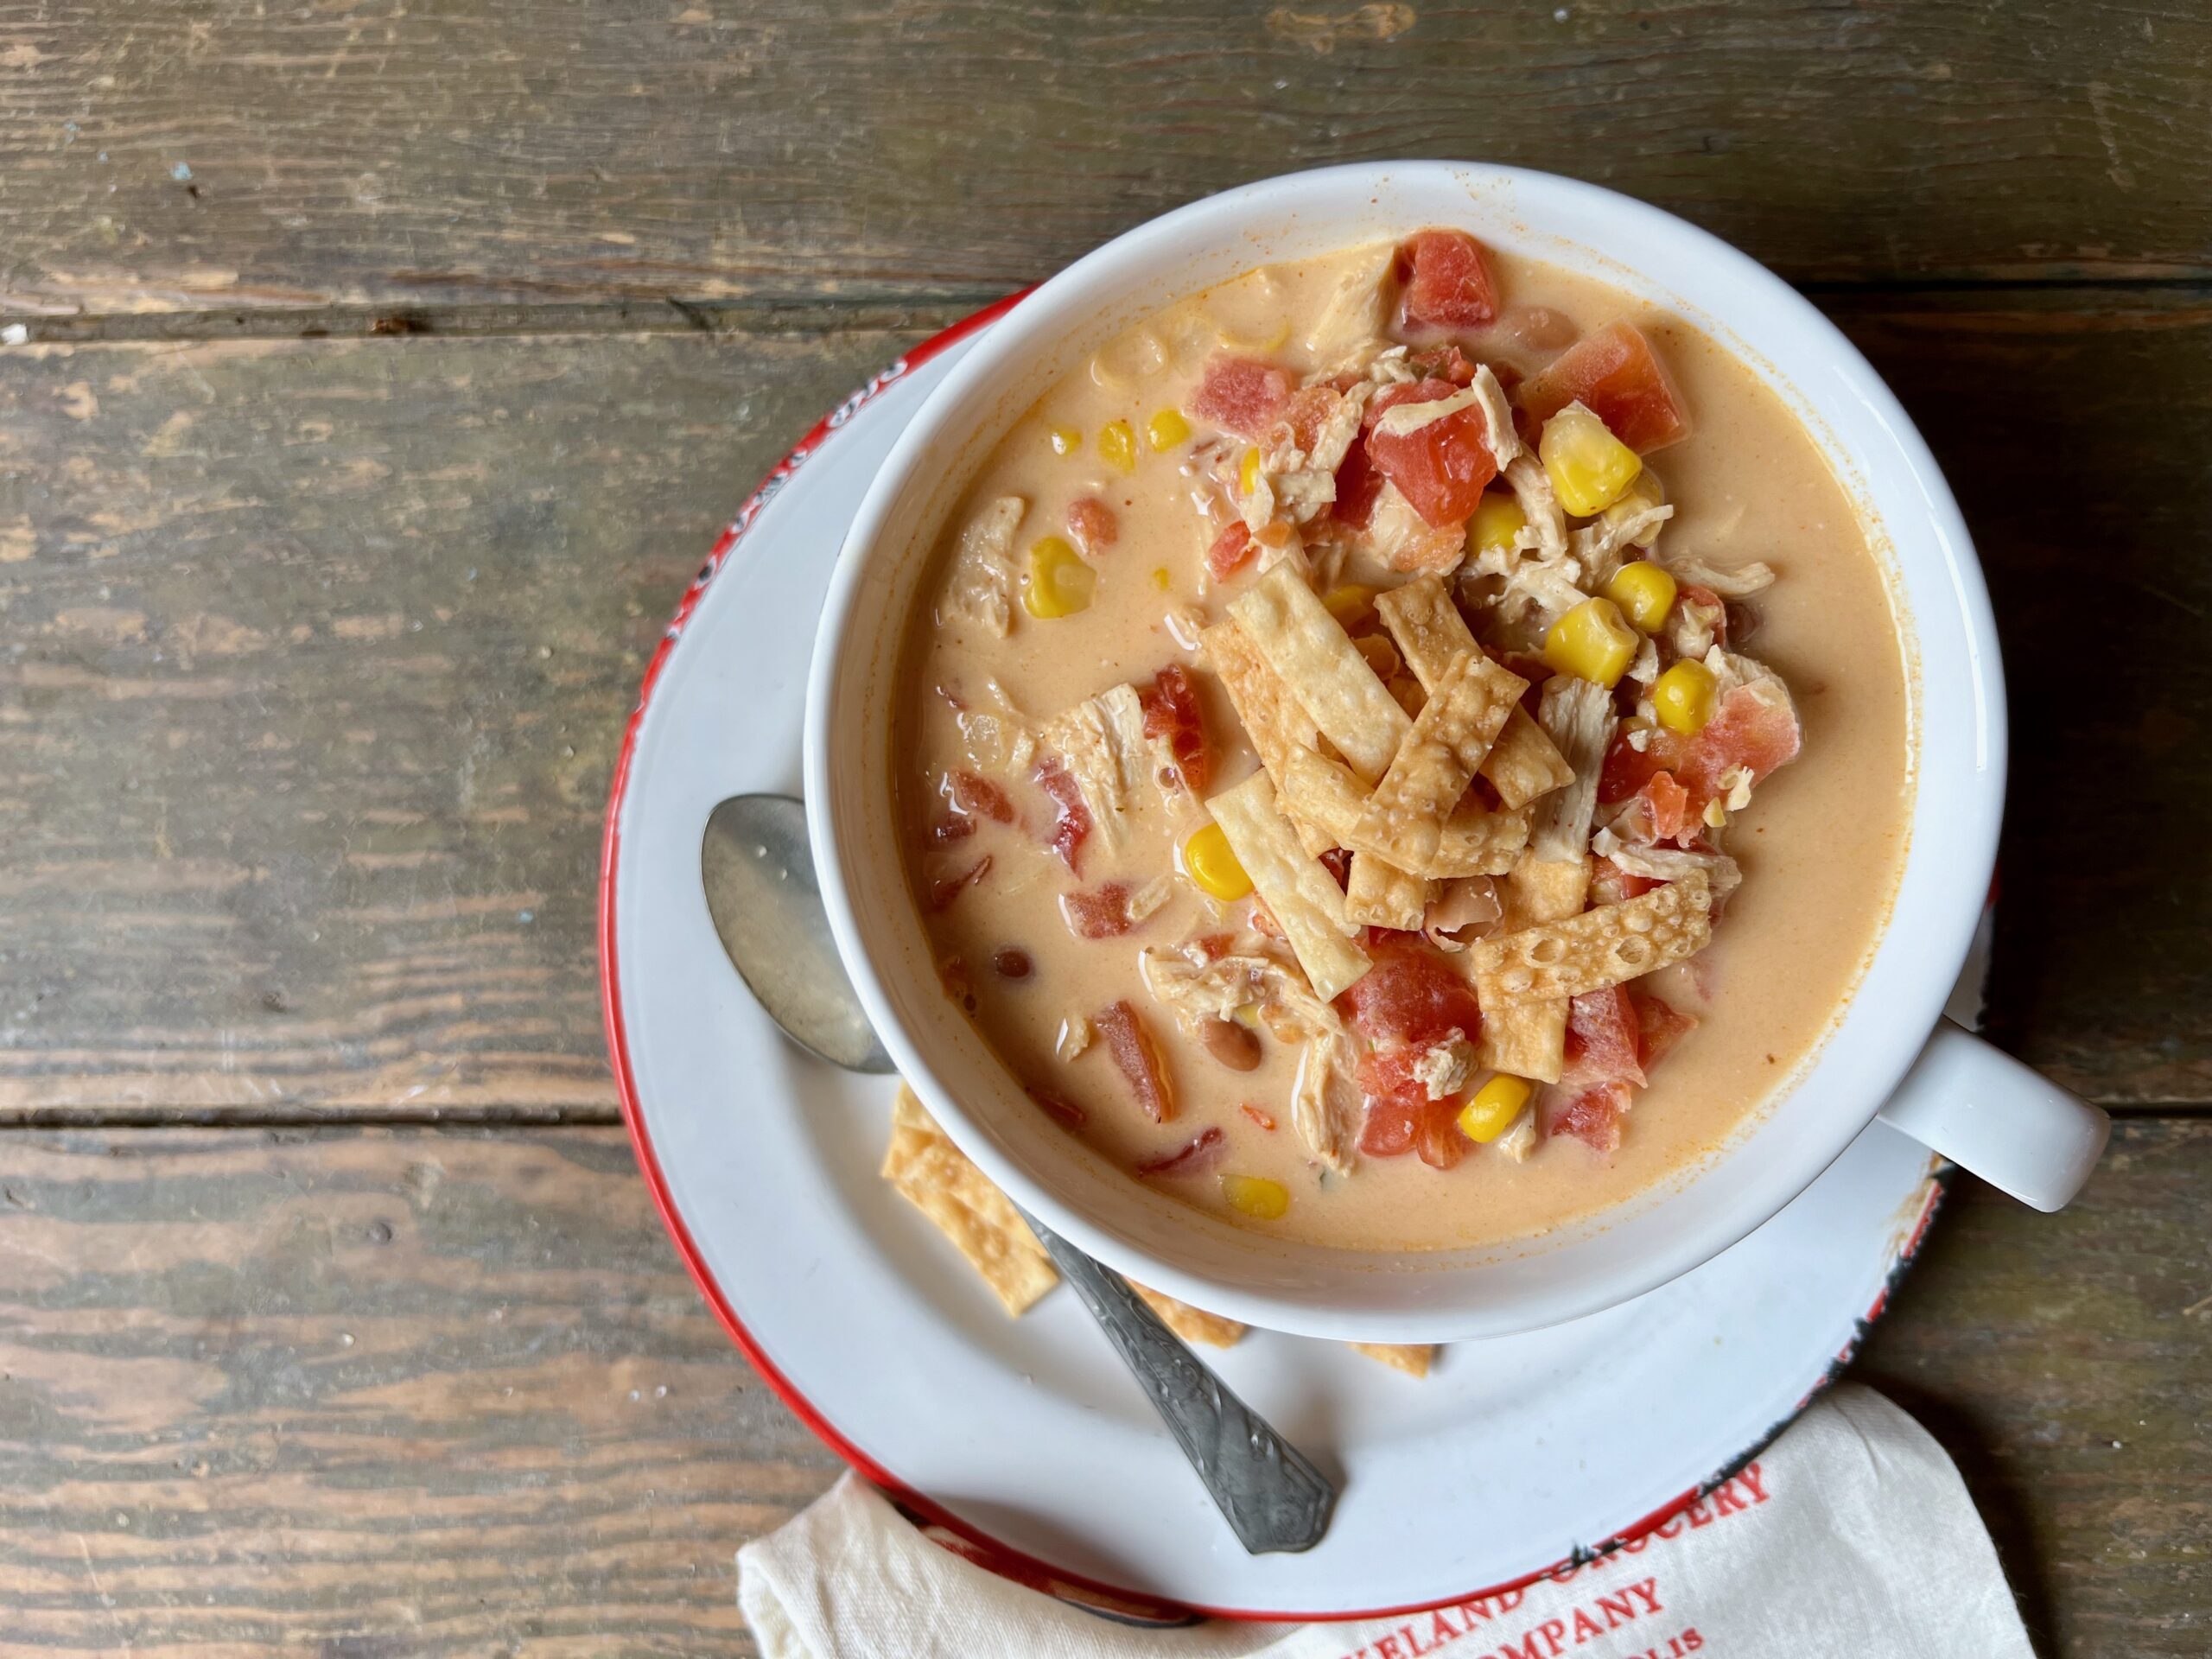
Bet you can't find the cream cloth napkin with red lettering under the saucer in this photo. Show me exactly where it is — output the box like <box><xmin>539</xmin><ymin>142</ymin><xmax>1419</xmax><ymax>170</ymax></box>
<box><xmin>736</xmin><ymin>1385</ymin><xmax>2033</xmax><ymax>1659</ymax></box>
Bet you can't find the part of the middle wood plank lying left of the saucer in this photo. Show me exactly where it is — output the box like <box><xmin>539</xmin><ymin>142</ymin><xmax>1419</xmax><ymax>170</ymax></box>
<box><xmin>0</xmin><ymin>321</ymin><xmax>955</xmax><ymax>1119</ymax></box>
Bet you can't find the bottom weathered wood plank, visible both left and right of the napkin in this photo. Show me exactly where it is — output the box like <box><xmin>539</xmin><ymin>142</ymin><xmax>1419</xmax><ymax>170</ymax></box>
<box><xmin>0</xmin><ymin>1122</ymin><xmax>2212</xmax><ymax>1659</ymax></box>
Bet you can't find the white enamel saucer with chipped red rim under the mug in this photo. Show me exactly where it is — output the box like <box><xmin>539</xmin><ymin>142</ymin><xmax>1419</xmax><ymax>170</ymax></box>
<box><xmin>600</xmin><ymin>301</ymin><xmax>1942</xmax><ymax>1619</ymax></box>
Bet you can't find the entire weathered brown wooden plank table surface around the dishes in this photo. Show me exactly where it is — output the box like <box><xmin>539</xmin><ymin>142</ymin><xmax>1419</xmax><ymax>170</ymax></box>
<box><xmin>0</xmin><ymin>0</ymin><xmax>2212</xmax><ymax>1656</ymax></box>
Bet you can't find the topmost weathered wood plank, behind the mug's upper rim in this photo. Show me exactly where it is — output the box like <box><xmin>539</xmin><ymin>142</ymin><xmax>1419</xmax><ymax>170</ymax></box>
<box><xmin>0</xmin><ymin>0</ymin><xmax>2212</xmax><ymax>312</ymax></box>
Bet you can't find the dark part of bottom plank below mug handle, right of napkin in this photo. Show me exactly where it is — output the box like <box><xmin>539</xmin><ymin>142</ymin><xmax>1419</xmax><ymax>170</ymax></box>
<box><xmin>1856</xmin><ymin>1119</ymin><xmax>2212</xmax><ymax>1659</ymax></box>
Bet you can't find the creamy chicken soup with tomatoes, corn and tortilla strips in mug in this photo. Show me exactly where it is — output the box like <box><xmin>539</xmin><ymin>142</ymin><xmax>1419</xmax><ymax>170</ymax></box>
<box><xmin>898</xmin><ymin>230</ymin><xmax>1909</xmax><ymax>1249</ymax></box>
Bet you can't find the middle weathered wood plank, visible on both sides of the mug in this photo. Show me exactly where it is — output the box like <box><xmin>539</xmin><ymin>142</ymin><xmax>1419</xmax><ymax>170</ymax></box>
<box><xmin>0</xmin><ymin>294</ymin><xmax>2212</xmax><ymax>1119</ymax></box>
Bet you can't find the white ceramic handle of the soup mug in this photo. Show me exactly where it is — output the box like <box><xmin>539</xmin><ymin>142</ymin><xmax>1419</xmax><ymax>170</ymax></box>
<box><xmin>1880</xmin><ymin>1020</ymin><xmax>2113</xmax><ymax>1210</ymax></box>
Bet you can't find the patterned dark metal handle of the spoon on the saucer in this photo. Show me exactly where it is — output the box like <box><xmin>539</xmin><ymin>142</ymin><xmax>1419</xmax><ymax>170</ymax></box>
<box><xmin>1024</xmin><ymin>1210</ymin><xmax>1336</xmax><ymax>1555</ymax></box>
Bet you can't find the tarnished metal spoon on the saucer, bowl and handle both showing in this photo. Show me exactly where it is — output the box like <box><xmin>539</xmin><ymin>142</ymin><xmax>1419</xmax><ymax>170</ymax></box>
<box><xmin>699</xmin><ymin>794</ymin><xmax>1336</xmax><ymax>1555</ymax></box>
